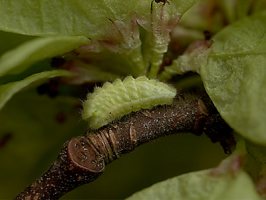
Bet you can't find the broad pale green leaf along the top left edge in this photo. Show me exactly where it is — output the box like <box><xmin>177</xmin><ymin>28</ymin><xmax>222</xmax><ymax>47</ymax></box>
<box><xmin>0</xmin><ymin>0</ymin><xmax>197</xmax><ymax>37</ymax></box>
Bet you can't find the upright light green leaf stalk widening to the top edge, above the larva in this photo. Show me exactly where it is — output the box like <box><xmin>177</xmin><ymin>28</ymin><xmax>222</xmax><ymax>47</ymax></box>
<box><xmin>142</xmin><ymin>0</ymin><xmax>198</xmax><ymax>78</ymax></box>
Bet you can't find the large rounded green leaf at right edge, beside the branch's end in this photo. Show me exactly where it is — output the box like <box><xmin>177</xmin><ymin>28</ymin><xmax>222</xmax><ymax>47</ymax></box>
<box><xmin>200</xmin><ymin>12</ymin><xmax>266</xmax><ymax>145</ymax></box>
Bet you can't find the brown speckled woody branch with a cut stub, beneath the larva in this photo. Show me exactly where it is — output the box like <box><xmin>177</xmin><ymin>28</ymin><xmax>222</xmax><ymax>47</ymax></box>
<box><xmin>16</xmin><ymin>93</ymin><xmax>234</xmax><ymax>200</ymax></box>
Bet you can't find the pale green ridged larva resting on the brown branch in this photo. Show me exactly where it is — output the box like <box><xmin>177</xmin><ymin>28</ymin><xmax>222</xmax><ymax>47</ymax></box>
<box><xmin>82</xmin><ymin>76</ymin><xmax>176</xmax><ymax>129</ymax></box>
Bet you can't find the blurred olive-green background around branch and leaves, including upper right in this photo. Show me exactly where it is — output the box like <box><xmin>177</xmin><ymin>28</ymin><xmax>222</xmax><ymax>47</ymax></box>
<box><xmin>0</xmin><ymin>0</ymin><xmax>266</xmax><ymax>199</ymax></box>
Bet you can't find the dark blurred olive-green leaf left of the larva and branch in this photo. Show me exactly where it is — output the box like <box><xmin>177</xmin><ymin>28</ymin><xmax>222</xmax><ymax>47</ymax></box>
<box><xmin>0</xmin><ymin>92</ymin><xmax>86</xmax><ymax>199</ymax></box>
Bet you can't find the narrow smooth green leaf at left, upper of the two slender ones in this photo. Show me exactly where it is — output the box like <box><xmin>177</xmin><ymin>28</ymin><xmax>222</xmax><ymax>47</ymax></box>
<box><xmin>0</xmin><ymin>36</ymin><xmax>88</xmax><ymax>76</ymax></box>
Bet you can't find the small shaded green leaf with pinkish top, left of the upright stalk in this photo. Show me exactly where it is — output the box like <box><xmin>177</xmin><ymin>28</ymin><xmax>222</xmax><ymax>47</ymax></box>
<box><xmin>76</xmin><ymin>41</ymin><xmax>146</xmax><ymax>76</ymax></box>
